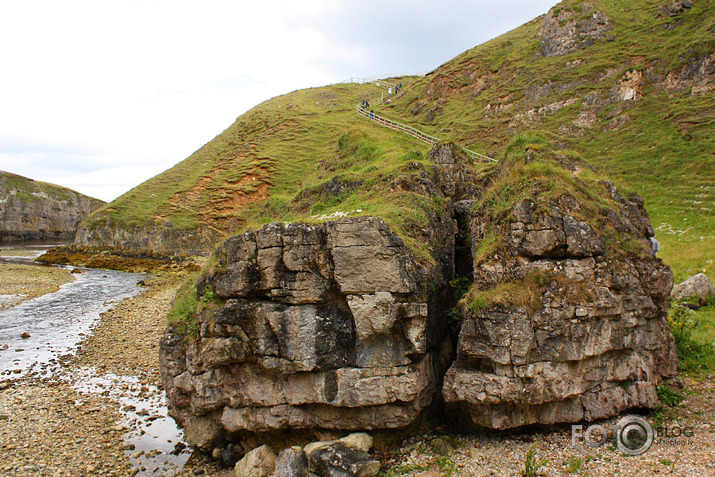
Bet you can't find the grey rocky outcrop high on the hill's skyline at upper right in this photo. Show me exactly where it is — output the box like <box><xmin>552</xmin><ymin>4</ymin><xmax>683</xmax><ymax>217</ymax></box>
<box><xmin>539</xmin><ymin>2</ymin><xmax>613</xmax><ymax>56</ymax></box>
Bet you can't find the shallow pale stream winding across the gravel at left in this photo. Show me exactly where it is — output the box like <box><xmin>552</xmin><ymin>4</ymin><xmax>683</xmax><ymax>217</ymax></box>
<box><xmin>0</xmin><ymin>243</ymin><xmax>190</xmax><ymax>475</ymax></box>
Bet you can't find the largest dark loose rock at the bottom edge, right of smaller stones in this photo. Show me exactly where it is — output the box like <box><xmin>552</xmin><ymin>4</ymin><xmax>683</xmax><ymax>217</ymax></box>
<box><xmin>308</xmin><ymin>442</ymin><xmax>380</xmax><ymax>477</ymax></box>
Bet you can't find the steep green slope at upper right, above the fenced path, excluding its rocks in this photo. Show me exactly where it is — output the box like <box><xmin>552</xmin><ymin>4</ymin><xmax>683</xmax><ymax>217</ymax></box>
<box><xmin>388</xmin><ymin>0</ymin><xmax>715</xmax><ymax>281</ymax></box>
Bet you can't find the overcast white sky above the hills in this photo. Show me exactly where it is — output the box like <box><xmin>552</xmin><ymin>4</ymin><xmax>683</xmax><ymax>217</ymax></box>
<box><xmin>0</xmin><ymin>0</ymin><xmax>557</xmax><ymax>201</ymax></box>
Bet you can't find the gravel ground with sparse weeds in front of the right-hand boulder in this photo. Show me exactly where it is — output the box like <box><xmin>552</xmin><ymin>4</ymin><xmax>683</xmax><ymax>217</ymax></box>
<box><xmin>374</xmin><ymin>376</ymin><xmax>715</xmax><ymax>477</ymax></box>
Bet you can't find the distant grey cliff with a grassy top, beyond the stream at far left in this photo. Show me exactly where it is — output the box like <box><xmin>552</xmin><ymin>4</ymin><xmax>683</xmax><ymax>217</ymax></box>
<box><xmin>0</xmin><ymin>171</ymin><xmax>103</xmax><ymax>242</ymax></box>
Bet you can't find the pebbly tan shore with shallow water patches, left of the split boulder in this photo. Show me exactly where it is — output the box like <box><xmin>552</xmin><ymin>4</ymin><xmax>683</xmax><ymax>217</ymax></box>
<box><xmin>0</xmin><ymin>265</ymin><xmax>230</xmax><ymax>477</ymax></box>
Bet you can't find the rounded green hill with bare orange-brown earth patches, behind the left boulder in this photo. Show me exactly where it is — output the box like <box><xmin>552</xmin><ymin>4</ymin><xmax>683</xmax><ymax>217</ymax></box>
<box><xmin>90</xmin><ymin>78</ymin><xmax>462</xmax><ymax>258</ymax></box>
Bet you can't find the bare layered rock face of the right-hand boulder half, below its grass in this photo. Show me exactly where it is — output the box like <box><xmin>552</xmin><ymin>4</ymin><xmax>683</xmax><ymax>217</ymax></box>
<box><xmin>443</xmin><ymin>183</ymin><xmax>678</xmax><ymax>429</ymax></box>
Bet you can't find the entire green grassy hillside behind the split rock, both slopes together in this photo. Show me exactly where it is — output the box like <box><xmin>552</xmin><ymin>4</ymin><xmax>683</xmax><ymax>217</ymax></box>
<box><xmin>85</xmin><ymin>0</ymin><xmax>715</xmax><ymax>281</ymax></box>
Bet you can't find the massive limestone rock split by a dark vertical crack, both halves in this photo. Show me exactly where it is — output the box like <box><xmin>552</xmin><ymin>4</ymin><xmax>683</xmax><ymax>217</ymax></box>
<box><xmin>160</xmin><ymin>145</ymin><xmax>678</xmax><ymax>449</ymax></box>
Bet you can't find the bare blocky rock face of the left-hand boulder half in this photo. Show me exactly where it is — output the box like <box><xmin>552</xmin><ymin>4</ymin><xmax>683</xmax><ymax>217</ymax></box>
<box><xmin>160</xmin><ymin>217</ymin><xmax>453</xmax><ymax>448</ymax></box>
